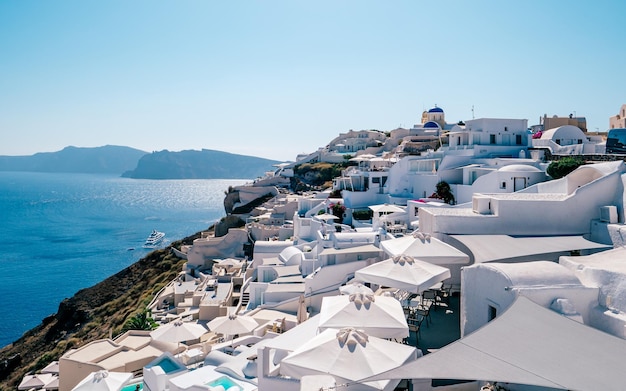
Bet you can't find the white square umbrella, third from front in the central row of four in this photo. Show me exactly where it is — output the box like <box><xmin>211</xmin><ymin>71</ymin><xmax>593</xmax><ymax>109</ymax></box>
<box><xmin>354</xmin><ymin>255</ymin><xmax>450</xmax><ymax>293</ymax></box>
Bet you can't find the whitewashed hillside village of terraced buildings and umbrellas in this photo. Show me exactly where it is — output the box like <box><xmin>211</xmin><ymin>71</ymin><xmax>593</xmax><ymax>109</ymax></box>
<box><xmin>19</xmin><ymin>105</ymin><xmax>626</xmax><ymax>391</ymax></box>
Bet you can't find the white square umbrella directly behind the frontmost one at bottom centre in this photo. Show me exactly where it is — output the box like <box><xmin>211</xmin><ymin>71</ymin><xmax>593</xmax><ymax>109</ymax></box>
<box><xmin>318</xmin><ymin>293</ymin><xmax>409</xmax><ymax>338</ymax></box>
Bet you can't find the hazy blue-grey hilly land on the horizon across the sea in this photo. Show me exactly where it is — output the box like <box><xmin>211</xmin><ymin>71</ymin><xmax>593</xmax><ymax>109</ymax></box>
<box><xmin>0</xmin><ymin>145</ymin><xmax>279</xmax><ymax>179</ymax></box>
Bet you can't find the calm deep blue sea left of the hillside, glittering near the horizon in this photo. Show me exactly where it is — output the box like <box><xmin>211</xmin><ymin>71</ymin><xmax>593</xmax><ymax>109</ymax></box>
<box><xmin>0</xmin><ymin>172</ymin><xmax>249</xmax><ymax>347</ymax></box>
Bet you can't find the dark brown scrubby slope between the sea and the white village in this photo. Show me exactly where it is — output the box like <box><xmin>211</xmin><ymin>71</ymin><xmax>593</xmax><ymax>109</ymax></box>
<box><xmin>0</xmin><ymin>233</ymin><xmax>200</xmax><ymax>391</ymax></box>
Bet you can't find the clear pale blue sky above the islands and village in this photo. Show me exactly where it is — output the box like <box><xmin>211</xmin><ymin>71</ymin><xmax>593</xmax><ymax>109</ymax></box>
<box><xmin>0</xmin><ymin>0</ymin><xmax>626</xmax><ymax>160</ymax></box>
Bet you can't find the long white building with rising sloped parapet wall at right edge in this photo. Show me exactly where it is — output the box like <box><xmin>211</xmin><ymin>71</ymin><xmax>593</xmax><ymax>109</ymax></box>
<box><xmin>419</xmin><ymin>161</ymin><xmax>626</xmax><ymax>243</ymax></box>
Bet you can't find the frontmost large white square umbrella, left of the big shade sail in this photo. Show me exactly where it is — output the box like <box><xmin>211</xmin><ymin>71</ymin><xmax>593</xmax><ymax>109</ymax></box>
<box><xmin>280</xmin><ymin>328</ymin><xmax>417</xmax><ymax>389</ymax></box>
